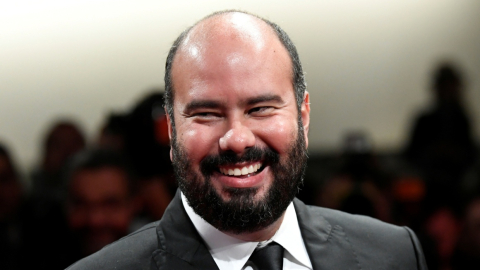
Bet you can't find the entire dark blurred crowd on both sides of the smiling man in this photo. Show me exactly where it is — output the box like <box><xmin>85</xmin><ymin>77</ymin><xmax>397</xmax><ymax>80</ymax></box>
<box><xmin>0</xmin><ymin>64</ymin><xmax>480</xmax><ymax>270</ymax></box>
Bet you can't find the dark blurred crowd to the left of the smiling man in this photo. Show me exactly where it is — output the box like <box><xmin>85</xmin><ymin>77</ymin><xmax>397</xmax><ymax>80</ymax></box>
<box><xmin>0</xmin><ymin>91</ymin><xmax>176</xmax><ymax>270</ymax></box>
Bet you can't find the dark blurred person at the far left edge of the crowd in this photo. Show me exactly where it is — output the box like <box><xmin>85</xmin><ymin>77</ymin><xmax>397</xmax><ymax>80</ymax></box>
<box><xmin>0</xmin><ymin>141</ymin><xmax>71</xmax><ymax>270</ymax></box>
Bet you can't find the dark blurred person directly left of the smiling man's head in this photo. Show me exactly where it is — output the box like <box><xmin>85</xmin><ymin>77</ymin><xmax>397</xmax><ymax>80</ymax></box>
<box><xmin>99</xmin><ymin>92</ymin><xmax>177</xmax><ymax>225</ymax></box>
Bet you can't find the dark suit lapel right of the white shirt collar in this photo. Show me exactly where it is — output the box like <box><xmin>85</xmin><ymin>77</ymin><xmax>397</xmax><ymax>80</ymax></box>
<box><xmin>293</xmin><ymin>199</ymin><xmax>361</xmax><ymax>270</ymax></box>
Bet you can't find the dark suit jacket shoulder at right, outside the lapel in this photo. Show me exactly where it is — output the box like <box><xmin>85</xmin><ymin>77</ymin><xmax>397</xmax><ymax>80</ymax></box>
<box><xmin>296</xmin><ymin>201</ymin><xmax>426</xmax><ymax>269</ymax></box>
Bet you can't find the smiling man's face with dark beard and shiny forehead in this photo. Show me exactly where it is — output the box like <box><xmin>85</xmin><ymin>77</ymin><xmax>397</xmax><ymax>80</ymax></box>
<box><xmin>170</xmin><ymin>14</ymin><xmax>309</xmax><ymax>233</ymax></box>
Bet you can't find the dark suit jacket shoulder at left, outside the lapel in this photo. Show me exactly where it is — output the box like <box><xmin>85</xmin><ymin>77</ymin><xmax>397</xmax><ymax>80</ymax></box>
<box><xmin>67</xmin><ymin>221</ymin><xmax>158</xmax><ymax>270</ymax></box>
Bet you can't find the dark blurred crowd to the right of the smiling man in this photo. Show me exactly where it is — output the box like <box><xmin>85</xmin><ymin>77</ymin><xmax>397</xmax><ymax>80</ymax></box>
<box><xmin>301</xmin><ymin>63</ymin><xmax>480</xmax><ymax>270</ymax></box>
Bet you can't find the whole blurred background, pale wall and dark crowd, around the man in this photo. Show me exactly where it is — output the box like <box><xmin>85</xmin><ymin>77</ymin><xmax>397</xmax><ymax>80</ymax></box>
<box><xmin>0</xmin><ymin>0</ymin><xmax>480</xmax><ymax>270</ymax></box>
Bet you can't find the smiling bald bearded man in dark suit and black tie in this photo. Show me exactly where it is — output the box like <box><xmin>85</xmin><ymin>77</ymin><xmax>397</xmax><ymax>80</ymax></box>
<box><xmin>66</xmin><ymin>11</ymin><xmax>426</xmax><ymax>269</ymax></box>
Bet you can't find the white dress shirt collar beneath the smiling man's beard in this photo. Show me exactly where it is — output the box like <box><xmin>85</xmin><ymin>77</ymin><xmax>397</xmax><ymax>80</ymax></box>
<box><xmin>182</xmin><ymin>193</ymin><xmax>312</xmax><ymax>270</ymax></box>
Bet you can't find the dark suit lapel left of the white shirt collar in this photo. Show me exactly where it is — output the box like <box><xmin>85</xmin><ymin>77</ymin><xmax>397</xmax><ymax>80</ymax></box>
<box><xmin>152</xmin><ymin>191</ymin><xmax>218</xmax><ymax>270</ymax></box>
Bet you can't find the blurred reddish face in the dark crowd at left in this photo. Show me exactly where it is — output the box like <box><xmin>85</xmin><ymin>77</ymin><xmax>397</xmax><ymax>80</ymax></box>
<box><xmin>68</xmin><ymin>167</ymin><xmax>133</xmax><ymax>255</ymax></box>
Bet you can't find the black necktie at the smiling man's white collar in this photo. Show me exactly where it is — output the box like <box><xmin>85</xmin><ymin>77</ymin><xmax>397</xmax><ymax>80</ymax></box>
<box><xmin>243</xmin><ymin>242</ymin><xmax>283</xmax><ymax>270</ymax></box>
